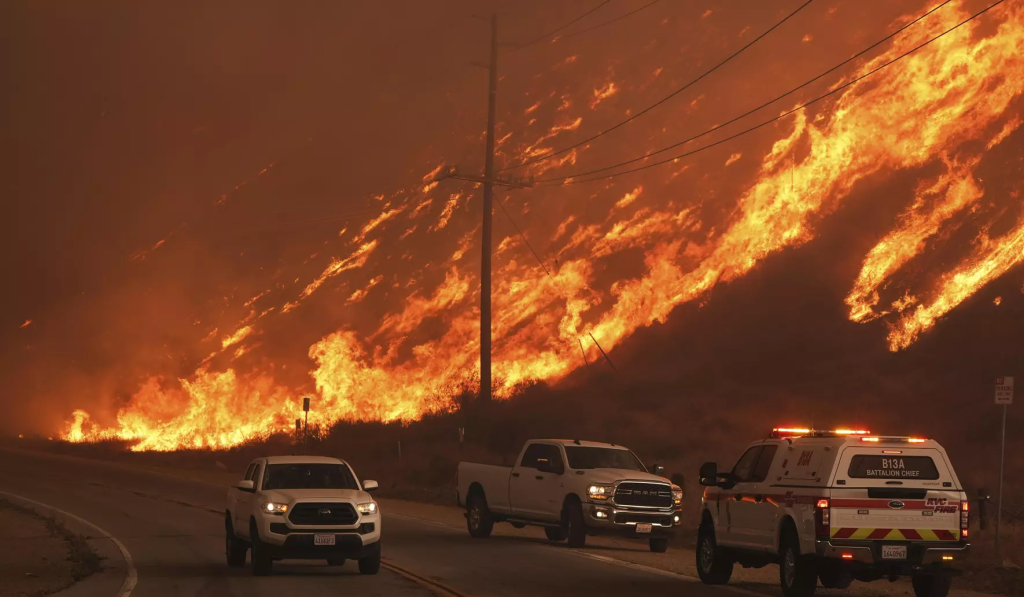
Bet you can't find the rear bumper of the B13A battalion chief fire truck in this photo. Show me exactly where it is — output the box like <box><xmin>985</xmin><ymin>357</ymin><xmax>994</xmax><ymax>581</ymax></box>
<box><xmin>815</xmin><ymin>540</ymin><xmax>970</xmax><ymax>570</ymax></box>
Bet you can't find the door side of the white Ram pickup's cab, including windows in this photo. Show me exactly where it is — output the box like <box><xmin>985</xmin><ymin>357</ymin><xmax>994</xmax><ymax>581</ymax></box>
<box><xmin>509</xmin><ymin>443</ymin><xmax>565</xmax><ymax>519</ymax></box>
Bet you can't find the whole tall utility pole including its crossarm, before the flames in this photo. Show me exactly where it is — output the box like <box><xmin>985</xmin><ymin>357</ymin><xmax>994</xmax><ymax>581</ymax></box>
<box><xmin>431</xmin><ymin>14</ymin><xmax>534</xmax><ymax>402</ymax></box>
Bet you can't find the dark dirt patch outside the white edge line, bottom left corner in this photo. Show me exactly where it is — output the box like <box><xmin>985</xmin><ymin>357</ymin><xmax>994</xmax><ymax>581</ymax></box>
<box><xmin>0</xmin><ymin>499</ymin><xmax>99</xmax><ymax>597</ymax></box>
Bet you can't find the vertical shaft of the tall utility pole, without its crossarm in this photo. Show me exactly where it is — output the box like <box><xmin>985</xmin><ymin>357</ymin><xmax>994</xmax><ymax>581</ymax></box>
<box><xmin>480</xmin><ymin>14</ymin><xmax>498</xmax><ymax>402</ymax></box>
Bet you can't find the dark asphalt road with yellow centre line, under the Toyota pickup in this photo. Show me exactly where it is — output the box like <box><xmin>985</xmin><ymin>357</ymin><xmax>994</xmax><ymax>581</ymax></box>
<box><xmin>0</xmin><ymin>450</ymin><xmax>736</xmax><ymax>597</ymax></box>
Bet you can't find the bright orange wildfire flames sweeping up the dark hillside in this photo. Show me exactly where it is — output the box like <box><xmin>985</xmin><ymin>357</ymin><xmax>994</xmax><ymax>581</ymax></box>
<box><xmin>61</xmin><ymin>2</ymin><xmax>1024</xmax><ymax>450</ymax></box>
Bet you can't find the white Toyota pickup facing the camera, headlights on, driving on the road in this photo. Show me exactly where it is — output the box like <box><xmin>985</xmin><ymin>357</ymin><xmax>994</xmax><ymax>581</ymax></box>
<box><xmin>224</xmin><ymin>456</ymin><xmax>381</xmax><ymax>577</ymax></box>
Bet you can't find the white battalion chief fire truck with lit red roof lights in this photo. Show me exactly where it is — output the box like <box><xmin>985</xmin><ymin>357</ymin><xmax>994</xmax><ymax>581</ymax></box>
<box><xmin>696</xmin><ymin>428</ymin><xmax>968</xmax><ymax>597</ymax></box>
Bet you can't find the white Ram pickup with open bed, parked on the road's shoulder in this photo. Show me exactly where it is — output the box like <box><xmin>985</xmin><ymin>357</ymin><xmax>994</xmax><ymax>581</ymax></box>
<box><xmin>456</xmin><ymin>439</ymin><xmax>683</xmax><ymax>553</ymax></box>
